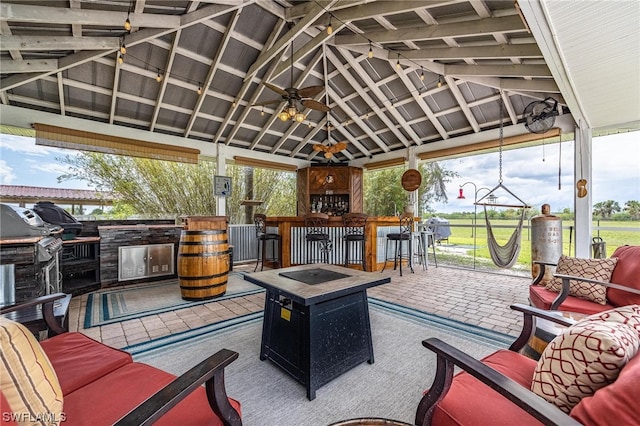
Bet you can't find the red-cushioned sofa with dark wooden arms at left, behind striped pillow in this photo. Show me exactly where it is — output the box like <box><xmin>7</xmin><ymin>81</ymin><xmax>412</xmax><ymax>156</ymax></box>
<box><xmin>0</xmin><ymin>293</ymin><xmax>242</xmax><ymax>426</ymax></box>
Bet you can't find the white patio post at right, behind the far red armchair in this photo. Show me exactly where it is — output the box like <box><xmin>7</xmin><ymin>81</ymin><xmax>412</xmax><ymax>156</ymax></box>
<box><xmin>573</xmin><ymin>120</ymin><xmax>593</xmax><ymax>258</ymax></box>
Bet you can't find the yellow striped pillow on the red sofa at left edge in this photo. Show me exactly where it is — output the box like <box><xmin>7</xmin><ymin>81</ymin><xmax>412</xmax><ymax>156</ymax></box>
<box><xmin>0</xmin><ymin>318</ymin><xmax>63</xmax><ymax>425</ymax></box>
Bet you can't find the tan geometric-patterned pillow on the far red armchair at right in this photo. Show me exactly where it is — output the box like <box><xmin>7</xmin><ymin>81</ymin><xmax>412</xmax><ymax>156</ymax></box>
<box><xmin>547</xmin><ymin>255</ymin><xmax>618</xmax><ymax>305</ymax></box>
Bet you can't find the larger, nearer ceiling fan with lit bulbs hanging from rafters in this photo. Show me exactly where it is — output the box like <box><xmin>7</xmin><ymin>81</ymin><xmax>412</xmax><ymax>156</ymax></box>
<box><xmin>253</xmin><ymin>43</ymin><xmax>331</xmax><ymax>122</ymax></box>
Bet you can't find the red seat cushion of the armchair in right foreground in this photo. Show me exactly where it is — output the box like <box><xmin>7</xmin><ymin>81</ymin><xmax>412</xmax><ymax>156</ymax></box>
<box><xmin>431</xmin><ymin>350</ymin><xmax>542</xmax><ymax>426</ymax></box>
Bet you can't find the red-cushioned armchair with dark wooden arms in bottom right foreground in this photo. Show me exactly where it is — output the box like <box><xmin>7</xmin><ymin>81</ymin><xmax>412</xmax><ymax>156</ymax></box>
<box><xmin>415</xmin><ymin>304</ymin><xmax>640</xmax><ymax>426</ymax></box>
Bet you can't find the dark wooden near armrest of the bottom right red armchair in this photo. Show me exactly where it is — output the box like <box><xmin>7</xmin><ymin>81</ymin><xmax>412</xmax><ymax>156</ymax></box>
<box><xmin>416</xmin><ymin>337</ymin><xmax>580</xmax><ymax>426</ymax></box>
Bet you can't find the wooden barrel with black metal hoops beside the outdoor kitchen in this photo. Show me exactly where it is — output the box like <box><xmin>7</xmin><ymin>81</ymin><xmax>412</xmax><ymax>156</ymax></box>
<box><xmin>178</xmin><ymin>230</ymin><xmax>229</xmax><ymax>300</ymax></box>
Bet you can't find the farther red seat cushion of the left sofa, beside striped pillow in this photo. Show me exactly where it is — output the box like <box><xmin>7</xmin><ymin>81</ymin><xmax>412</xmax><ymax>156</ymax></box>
<box><xmin>40</xmin><ymin>332</ymin><xmax>133</xmax><ymax>394</ymax></box>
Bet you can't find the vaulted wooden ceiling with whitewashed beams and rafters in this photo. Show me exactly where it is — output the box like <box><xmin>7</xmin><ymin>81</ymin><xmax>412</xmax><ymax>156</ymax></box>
<box><xmin>0</xmin><ymin>0</ymin><xmax>636</xmax><ymax>166</ymax></box>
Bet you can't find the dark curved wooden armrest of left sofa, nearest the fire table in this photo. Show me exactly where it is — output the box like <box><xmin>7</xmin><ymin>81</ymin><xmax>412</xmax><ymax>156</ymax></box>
<box><xmin>116</xmin><ymin>349</ymin><xmax>242</xmax><ymax>426</ymax></box>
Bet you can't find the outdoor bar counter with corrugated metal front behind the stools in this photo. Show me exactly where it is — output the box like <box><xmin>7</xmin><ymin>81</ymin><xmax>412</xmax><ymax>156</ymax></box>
<box><xmin>267</xmin><ymin>216</ymin><xmax>410</xmax><ymax>271</ymax></box>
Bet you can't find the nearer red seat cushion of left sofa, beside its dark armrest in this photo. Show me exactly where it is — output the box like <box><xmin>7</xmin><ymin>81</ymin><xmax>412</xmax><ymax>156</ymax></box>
<box><xmin>64</xmin><ymin>363</ymin><xmax>240</xmax><ymax>426</ymax></box>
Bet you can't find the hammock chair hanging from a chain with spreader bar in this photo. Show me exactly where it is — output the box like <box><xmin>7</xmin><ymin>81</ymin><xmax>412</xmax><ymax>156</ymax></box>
<box><xmin>475</xmin><ymin>92</ymin><xmax>530</xmax><ymax>269</ymax></box>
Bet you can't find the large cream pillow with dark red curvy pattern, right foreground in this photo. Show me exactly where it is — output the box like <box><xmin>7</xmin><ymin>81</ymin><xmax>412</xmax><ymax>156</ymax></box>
<box><xmin>531</xmin><ymin>320</ymin><xmax>640</xmax><ymax>413</ymax></box>
